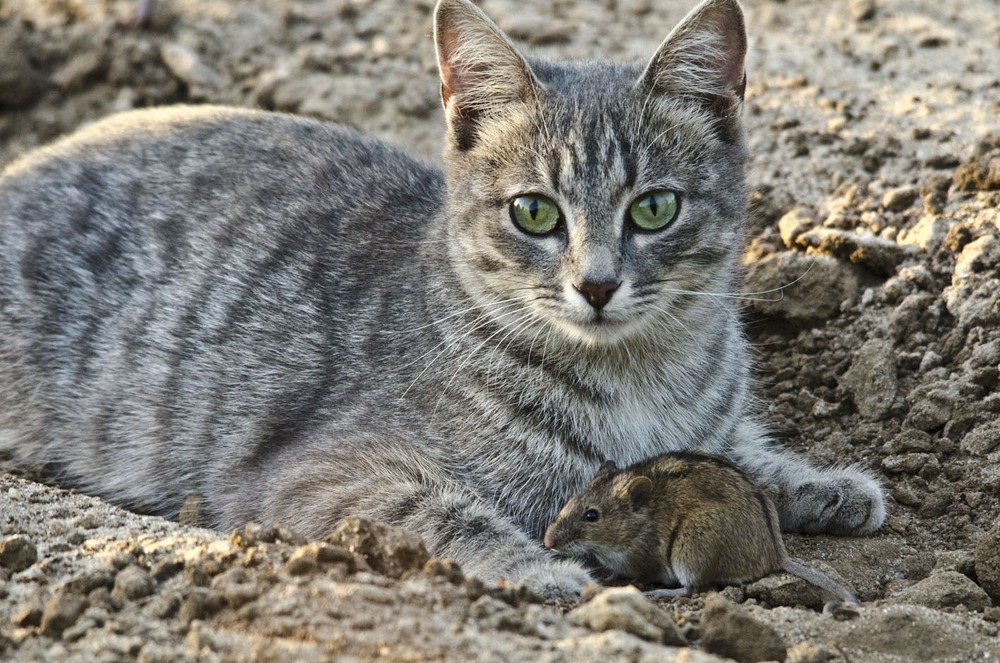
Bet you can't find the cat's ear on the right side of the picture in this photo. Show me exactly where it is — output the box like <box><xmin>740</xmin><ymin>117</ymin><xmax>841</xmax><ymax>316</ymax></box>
<box><xmin>639</xmin><ymin>0</ymin><xmax>747</xmax><ymax>118</ymax></box>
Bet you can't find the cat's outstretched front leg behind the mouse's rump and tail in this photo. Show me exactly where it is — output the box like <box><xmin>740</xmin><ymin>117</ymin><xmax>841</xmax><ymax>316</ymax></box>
<box><xmin>727</xmin><ymin>422</ymin><xmax>886</xmax><ymax>535</ymax></box>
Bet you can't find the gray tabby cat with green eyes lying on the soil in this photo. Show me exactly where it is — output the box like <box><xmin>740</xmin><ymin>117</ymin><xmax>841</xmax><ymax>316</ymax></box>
<box><xmin>0</xmin><ymin>0</ymin><xmax>885</xmax><ymax>596</ymax></box>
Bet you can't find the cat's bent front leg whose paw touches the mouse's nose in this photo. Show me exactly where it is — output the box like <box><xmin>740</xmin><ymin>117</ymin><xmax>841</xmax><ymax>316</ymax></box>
<box><xmin>252</xmin><ymin>439</ymin><xmax>593</xmax><ymax>598</ymax></box>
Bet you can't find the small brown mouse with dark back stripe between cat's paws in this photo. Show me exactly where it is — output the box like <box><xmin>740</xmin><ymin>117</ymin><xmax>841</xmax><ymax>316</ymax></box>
<box><xmin>545</xmin><ymin>451</ymin><xmax>858</xmax><ymax>603</ymax></box>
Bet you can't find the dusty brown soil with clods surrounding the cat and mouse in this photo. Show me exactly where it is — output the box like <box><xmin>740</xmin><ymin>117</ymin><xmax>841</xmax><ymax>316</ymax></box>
<box><xmin>0</xmin><ymin>0</ymin><xmax>1000</xmax><ymax>662</ymax></box>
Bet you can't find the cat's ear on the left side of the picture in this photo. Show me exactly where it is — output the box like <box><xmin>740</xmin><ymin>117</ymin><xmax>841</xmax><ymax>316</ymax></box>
<box><xmin>434</xmin><ymin>0</ymin><xmax>538</xmax><ymax>150</ymax></box>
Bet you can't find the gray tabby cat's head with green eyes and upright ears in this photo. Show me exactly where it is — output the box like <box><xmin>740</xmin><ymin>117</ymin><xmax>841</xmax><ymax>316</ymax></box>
<box><xmin>435</xmin><ymin>0</ymin><xmax>746</xmax><ymax>346</ymax></box>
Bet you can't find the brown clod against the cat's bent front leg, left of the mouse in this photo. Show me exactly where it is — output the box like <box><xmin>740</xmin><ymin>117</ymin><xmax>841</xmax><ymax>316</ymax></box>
<box><xmin>326</xmin><ymin>516</ymin><xmax>430</xmax><ymax>578</ymax></box>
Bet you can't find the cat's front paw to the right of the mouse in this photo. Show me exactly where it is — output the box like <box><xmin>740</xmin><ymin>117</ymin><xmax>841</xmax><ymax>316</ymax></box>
<box><xmin>778</xmin><ymin>469</ymin><xmax>885</xmax><ymax>536</ymax></box>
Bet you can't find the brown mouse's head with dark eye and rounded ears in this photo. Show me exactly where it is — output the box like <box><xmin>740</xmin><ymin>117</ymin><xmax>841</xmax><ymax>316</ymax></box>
<box><xmin>545</xmin><ymin>460</ymin><xmax>653</xmax><ymax>569</ymax></box>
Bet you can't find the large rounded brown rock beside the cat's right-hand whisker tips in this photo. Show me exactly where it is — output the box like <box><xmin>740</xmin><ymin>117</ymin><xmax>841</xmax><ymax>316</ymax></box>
<box><xmin>746</xmin><ymin>252</ymin><xmax>860</xmax><ymax>323</ymax></box>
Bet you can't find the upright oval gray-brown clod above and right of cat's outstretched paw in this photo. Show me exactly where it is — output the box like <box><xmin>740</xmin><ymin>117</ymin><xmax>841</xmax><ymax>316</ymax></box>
<box><xmin>840</xmin><ymin>339</ymin><xmax>899</xmax><ymax>421</ymax></box>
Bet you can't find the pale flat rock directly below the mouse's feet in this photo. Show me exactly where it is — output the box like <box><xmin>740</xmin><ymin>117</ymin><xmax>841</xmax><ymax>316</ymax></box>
<box><xmin>567</xmin><ymin>587</ymin><xmax>687</xmax><ymax>646</ymax></box>
